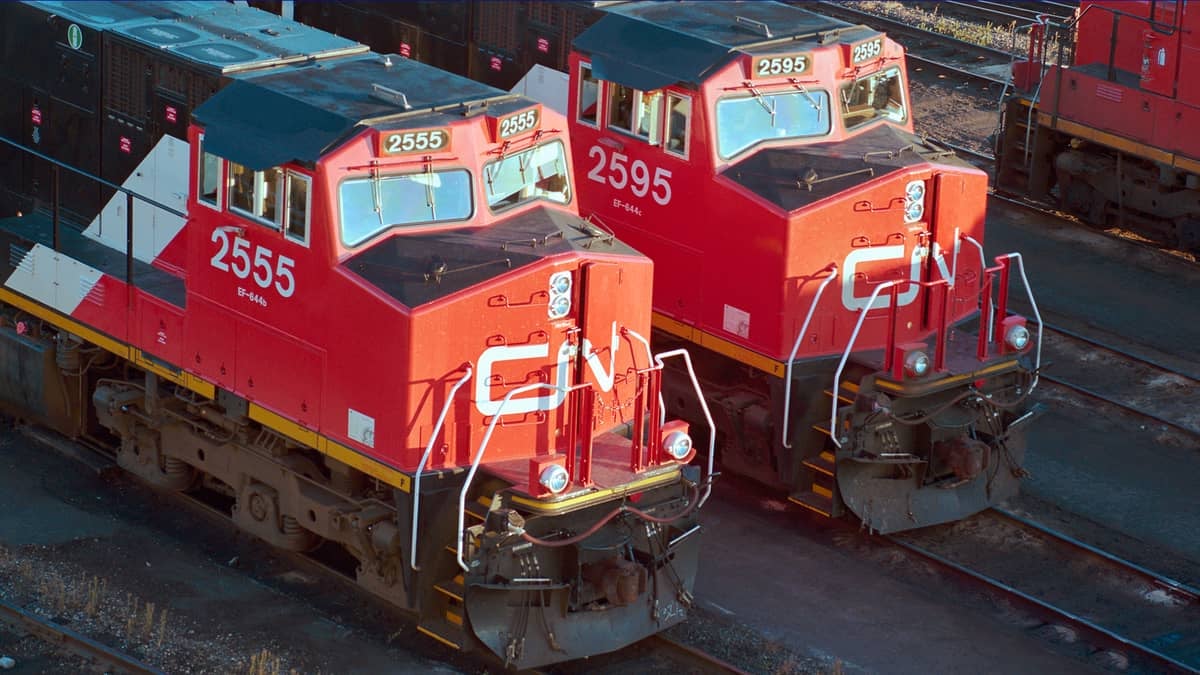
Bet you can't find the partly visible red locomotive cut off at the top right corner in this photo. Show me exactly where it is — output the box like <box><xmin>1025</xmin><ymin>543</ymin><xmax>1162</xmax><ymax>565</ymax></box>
<box><xmin>996</xmin><ymin>1</ymin><xmax>1200</xmax><ymax>252</ymax></box>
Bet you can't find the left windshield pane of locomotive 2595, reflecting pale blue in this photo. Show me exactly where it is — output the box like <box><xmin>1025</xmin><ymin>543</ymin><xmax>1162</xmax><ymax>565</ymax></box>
<box><xmin>716</xmin><ymin>91</ymin><xmax>829</xmax><ymax>159</ymax></box>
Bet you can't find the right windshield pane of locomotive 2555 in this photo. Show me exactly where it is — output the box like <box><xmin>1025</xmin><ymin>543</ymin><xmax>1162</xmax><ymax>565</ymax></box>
<box><xmin>484</xmin><ymin>141</ymin><xmax>571</xmax><ymax>210</ymax></box>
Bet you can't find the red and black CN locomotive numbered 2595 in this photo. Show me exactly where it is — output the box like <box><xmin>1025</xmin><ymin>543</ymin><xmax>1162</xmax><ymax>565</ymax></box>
<box><xmin>276</xmin><ymin>1</ymin><xmax>1039</xmax><ymax>532</ymax></box>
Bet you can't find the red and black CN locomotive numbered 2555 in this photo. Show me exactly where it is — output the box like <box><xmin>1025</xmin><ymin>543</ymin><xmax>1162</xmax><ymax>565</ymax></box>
<box><xmin>0</xmin><ymin>2</ymin><xmax>712</xmax><ymax>668</ymax></box>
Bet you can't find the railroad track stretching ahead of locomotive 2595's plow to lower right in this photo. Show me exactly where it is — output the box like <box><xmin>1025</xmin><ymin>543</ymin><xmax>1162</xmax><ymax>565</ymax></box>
<box><xmin>887</xmin><ymin>509</ymin><xmax>1200</xmax><ymax>673</ymax></box>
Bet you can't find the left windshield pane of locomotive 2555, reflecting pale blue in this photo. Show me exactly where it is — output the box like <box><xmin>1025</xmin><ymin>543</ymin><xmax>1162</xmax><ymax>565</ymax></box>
<box><xmin>338</xmin><ymin>169</ymin><xmax>473</xmax><ymax>246</ymax></box>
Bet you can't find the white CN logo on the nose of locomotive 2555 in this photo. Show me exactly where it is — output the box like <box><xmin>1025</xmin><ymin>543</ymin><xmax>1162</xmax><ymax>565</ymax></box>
<box><xmin>475</xmin><ymin>322</ymin><xmax>620</xmax><ymax>416</ymax></box>
